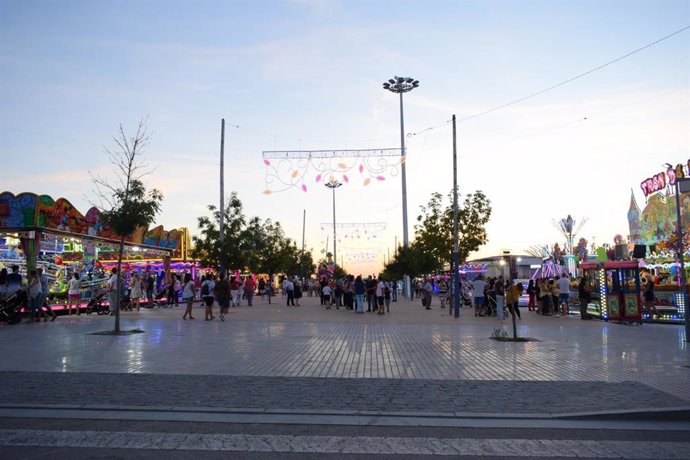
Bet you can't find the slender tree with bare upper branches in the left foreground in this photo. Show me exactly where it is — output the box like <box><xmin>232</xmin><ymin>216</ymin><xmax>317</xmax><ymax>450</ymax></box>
<box><xmin>91</xmin><ymin>119</ymin><xmax>163</xmax><ymax>334</ymax></box>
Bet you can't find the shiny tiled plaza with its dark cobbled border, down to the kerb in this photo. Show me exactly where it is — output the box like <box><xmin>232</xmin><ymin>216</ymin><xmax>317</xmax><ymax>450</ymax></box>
<box><xmin>0</xmin><ymin>292</ymin><xmax>690</xmax><ymax>415</ymax></box>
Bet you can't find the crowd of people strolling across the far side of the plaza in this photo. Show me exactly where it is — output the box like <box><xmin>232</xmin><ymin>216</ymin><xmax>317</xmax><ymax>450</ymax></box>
<box><xmin>0</xmin><ymin>260</ymin><xmax>596</xmax><ymax>321</ymax></box>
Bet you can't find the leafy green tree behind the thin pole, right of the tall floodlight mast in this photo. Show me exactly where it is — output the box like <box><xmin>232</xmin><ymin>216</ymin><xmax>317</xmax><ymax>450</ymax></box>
<box><xmin>415</xmin><ymin>190</ymin><xmax>491</xmax><ymax>270</ymax></box>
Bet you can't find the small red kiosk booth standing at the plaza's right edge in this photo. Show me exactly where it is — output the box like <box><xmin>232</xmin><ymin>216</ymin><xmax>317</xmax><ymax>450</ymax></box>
<box><xmin>580</xmin><ymin>261</ymin><xmax>642</xmax><ymax>324</ymax></box>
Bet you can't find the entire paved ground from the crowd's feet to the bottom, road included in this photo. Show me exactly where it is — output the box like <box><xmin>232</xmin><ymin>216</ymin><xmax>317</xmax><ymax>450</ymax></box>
<box><xmin>0</xmin><ymin>292</ymin><xmax>690</xmax><ymax>460</ymax></box>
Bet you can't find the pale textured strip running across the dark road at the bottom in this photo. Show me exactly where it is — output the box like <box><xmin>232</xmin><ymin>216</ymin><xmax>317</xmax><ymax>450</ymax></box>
<box><xmin>0</xmin><ymin>430</ymin><xmax>690</xmax><ymax>459</ymax></box>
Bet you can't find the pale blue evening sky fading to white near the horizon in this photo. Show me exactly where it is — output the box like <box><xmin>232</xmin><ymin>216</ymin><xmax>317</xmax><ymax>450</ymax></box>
<box><xmin>0</xmin><ymin>0</ymin><xmax>690</xmax><ymax>274</ymax></box>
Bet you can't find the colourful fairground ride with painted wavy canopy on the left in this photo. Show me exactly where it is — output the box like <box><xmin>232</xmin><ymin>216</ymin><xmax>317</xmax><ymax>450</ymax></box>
<box><xmin>0</xmin><ymin>192</ymin><xmax>196</xmax><ymax>303</ymax></box>
